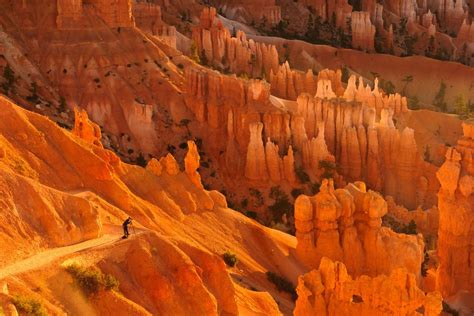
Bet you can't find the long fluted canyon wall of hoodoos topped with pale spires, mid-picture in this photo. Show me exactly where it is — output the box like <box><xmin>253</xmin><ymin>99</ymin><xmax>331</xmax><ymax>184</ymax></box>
<box><xmin>185</xmin><ymin>68</ymin><xmax>439</xmax><ymax>209</ymax></box>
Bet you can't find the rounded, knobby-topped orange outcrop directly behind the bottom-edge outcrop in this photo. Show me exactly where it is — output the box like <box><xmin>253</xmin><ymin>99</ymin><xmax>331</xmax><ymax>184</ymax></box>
<box><xmin>295</xmin><ymin>180</ymin><xmax>424</xmax><ymax>276</ymax></box>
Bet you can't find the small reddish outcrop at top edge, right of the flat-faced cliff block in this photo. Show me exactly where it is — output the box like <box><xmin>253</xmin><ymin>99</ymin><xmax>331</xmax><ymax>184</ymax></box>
<box><xmin>133</xmin><ymin>0</ymin><xmax>176</xmax><ymax>48</ymax></box>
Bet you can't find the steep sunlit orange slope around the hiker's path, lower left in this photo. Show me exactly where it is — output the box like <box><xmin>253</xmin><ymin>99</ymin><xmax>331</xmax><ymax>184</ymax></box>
<box><xmin>0</xmin><ymin>97</ymin><xmax>303</xmax><ymax>315</ymax></box>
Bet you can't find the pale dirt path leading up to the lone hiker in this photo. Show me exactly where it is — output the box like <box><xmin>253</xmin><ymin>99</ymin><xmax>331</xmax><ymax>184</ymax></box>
<box><xmin>0</xmin><ymin>229</ymin><xmax>143</xmax><ymax>280</ymax></box>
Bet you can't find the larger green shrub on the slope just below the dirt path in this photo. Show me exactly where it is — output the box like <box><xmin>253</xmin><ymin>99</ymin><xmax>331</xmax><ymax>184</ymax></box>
<box><xmin>66</xmin><ymin>264</ymin><xmax>120</xmax><ymax>296</ymax></box>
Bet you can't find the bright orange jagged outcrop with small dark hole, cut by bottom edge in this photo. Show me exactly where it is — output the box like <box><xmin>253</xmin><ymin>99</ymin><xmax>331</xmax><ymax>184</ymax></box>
<box><xmin>293</xmin><ymin>258</ymin><xmax>443</xmax><ymax>316</ymax></box>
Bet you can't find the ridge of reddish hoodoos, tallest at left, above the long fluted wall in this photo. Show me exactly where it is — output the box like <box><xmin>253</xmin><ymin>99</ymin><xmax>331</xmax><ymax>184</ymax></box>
<box><xmin>192</xmin><ymin>8</ymin><xmax>279</xmax><ymax>78</ymax></box>
